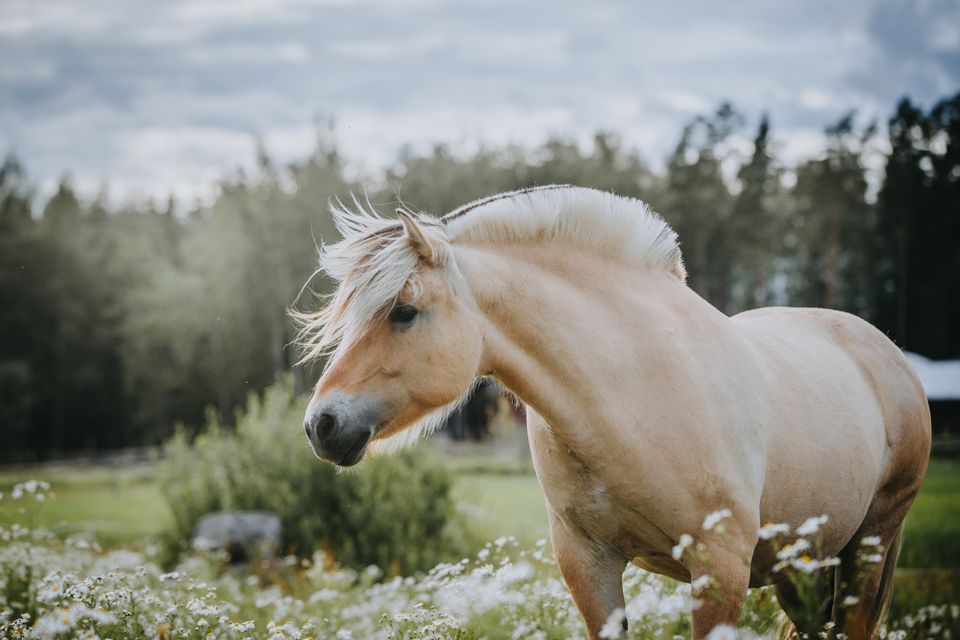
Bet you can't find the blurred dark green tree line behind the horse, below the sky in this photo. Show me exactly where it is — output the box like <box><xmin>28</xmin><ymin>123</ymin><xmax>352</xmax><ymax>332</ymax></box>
<box><xmin>0</xmin><ymin>94</ymin><xmax>960</xmax><ymax>457</ymax></box>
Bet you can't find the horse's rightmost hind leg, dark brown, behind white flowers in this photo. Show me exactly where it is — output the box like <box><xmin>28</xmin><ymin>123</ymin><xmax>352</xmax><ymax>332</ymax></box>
<box><xmin>833</xmin><ymin>523</ymin><xmax>903</xmax><ymax>640</ymax></box>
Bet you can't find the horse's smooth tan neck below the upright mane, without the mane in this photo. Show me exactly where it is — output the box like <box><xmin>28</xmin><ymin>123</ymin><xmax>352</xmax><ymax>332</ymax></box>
<box><xmin>457</xmin><ymin>245</ymin><xmax>723</xmax><ymax>448</ymax></box>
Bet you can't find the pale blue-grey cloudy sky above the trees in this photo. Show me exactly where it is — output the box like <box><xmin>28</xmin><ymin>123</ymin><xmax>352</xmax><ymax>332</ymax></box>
<box><xmin>0</xmin><ymin>0</ymin><xmax>960</xmax><ymax>205</ymax></box>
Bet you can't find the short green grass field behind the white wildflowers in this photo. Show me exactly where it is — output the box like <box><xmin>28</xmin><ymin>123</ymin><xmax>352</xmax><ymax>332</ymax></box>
<box><xmin>0</xmin><ymin>458</ymin><xmax>960</xmax><ymax>569</ymax></box>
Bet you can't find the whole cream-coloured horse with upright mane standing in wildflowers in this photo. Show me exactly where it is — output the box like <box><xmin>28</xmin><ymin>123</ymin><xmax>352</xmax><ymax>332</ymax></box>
<box><xmin>301</xmin><ymin>186</ymin><xmax>930</xmax><ymax>638</ymax></box>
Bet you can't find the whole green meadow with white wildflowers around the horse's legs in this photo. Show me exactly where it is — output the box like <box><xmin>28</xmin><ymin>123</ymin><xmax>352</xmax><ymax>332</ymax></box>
<box><xmin>0</xmin><ymin>452</ymin><xmax>960</xmax><ymax>640</ymax></box>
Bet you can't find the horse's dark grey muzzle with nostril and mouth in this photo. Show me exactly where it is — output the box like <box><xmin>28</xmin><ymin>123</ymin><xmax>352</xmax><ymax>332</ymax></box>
<box><xmin>303</xmin><ymin>394</ymin><xmax>377</xmax><ymax>467</ymax></box>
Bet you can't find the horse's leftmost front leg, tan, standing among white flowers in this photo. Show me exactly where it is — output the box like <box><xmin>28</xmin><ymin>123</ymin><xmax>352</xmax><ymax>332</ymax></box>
<box><xmin>550</xmin><ymin>510</ymin><xmax>627</xmax><ymax>639</ymax></box>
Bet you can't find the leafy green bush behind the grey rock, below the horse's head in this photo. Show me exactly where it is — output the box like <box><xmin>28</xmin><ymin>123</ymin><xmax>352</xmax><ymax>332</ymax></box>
<box><xmin>161</xmin><ymin>381</ymin><xmax>460</xmax><ymax>574</ymax></box>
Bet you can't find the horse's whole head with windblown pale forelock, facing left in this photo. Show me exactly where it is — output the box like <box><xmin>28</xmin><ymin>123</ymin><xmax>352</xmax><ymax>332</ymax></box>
<box><xmin>302</xmin><ymin>211</ymin><xmax>482</xmax><ymax>467</ymax></box>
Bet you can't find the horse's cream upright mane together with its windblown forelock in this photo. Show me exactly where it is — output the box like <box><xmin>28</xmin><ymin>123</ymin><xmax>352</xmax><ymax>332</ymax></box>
<box><xmin>292</xmin><ymin>185</ymin><xmax>686</xmax><ymax>362</ymax></box>
